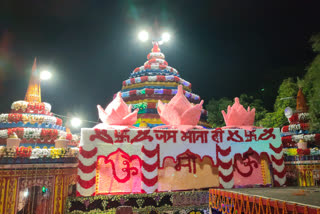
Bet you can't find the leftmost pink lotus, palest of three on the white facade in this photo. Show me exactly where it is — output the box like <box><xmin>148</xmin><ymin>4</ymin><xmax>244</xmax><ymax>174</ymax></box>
<box><xmin>94</xmin><ymin>92</ymin><xmax>139</xmax><ymax>129</ymax></box>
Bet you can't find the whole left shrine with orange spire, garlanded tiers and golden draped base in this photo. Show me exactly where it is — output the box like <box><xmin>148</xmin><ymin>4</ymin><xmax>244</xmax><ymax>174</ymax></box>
<box><xmin>0</xmin><ymin>57</ymin><xmax>79</xmax><ymax>214</ymax></box>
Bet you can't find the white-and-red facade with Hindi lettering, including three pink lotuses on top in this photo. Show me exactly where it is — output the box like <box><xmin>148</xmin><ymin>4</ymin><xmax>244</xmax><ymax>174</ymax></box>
<box><xmin>77</xmin><ymin>81</ymin><xmax>285</xmax><ymax>196</ymax></box>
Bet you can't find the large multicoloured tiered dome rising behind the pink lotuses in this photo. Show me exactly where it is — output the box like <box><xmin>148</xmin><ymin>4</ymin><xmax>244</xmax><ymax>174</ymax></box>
<box><xmin>121</xmin><ymin>42</ymin><xmax>210</xmax><ymax>128</ymax></box>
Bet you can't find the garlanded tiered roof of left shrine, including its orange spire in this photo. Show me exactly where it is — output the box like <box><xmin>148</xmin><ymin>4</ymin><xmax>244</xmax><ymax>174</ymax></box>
<box><xmin>0</xmin><ymin>59</ymin><xmax>77</xmax><ymax>147</ymax></box>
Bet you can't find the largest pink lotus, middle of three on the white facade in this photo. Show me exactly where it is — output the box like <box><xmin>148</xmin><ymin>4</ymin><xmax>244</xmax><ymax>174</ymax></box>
<box><xmin>155</xmin><ymin>85</ymin><xmax>203</xmax><ymax>131</ymax></box>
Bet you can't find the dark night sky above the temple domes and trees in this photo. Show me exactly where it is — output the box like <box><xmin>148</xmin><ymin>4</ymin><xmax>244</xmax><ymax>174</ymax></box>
<box><xmin>0</xmin><ymin>0</ymin><xmax>320</xmax><ymax>131</ymax></box>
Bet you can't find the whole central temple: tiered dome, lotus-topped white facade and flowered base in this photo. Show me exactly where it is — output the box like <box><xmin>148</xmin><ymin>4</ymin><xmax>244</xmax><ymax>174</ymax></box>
<box><xmin>74</xmin><ymin>43</ymin><xmax>286</xmax><ymax>214</ymax></box>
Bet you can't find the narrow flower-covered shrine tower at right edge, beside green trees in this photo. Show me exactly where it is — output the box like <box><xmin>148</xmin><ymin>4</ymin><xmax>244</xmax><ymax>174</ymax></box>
<box><xmin>281</xmin><ymin>88</ymin><xmax>320</xmax><ymax>186</ymax></box>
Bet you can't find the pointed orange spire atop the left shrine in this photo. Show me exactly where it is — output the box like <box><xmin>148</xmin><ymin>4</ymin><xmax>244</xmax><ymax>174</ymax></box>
<box><xmin>24</xmin><ymin>58</ymin><xmax>41</xmax><ymax>103</ymax></box>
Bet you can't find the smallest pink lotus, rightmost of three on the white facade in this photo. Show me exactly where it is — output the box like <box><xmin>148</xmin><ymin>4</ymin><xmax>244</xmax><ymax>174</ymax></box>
<box><xmin>221</xmin><ymin>97</ymin><xmax>256</xmax><ymax>130</ymax></box>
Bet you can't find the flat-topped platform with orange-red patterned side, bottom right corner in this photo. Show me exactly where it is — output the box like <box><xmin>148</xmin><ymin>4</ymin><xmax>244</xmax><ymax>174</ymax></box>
<box><xmin>209</xmin><ymin>187</ymin><xmax>320</xmax><ymax>214</ymax></box>
